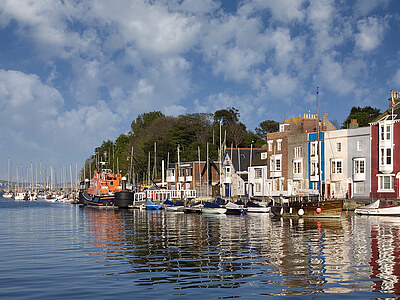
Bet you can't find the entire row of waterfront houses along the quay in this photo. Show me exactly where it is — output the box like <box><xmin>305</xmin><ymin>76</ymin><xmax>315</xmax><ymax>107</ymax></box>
<box><xmin>166</xmin><ymin>92</ymin><xmax>400</xmax><ymax>199</ymax></box>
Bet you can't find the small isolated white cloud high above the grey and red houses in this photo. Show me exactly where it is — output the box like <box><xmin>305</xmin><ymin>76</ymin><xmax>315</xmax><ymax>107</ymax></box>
<box><xmin>355</xmin><ymin>17</ymin><xmax>387</xmax><ymax>51</ymax></box>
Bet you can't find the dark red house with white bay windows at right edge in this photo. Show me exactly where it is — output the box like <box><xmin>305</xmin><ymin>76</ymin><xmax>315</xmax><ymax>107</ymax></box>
<box><xmin>370</xmin><ymin>92</ymin><xmax>400</xmax><ymax>198</ymax></box>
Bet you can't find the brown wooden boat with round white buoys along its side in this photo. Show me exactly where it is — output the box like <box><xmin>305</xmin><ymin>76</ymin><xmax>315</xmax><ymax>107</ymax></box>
<box><xmin>271</xmin><ymin>196</ymin><xmax>343</xmax><ymax>218</ymax></box>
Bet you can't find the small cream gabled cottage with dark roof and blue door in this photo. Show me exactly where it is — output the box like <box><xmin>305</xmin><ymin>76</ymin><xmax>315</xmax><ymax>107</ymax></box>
<box><xmin>221</xmin><ymin>148</ymin><xmax>265</xmax><ymax>197</ymax></box>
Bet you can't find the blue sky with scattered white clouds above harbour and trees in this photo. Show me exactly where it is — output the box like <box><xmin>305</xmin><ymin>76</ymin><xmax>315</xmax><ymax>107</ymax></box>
<box><xmin>0</xmin><ymin>0</ymin><xmax>400</xmax><ymax>180</ymax></box>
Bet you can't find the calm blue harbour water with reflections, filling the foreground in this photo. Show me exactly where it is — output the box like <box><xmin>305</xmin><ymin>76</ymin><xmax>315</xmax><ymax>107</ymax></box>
<box><xmin>0</xmin><ymin>198</ymin><xmax>400</xmax><ymax>299</ymax></box>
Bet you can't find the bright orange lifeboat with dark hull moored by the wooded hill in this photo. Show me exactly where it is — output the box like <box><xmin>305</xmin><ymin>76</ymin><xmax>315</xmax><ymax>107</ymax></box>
<box><xmin>84</xmin><ymin>169</ymin><xmax>122</xmax><ymax>208</ymax></box>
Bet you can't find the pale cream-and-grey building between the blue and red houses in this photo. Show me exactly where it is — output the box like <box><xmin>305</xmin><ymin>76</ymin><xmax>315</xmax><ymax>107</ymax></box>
<box><xmin>325</xmin><ymin>120</ymin><xmax>370</xmax><ymax>198</ymax></box>
